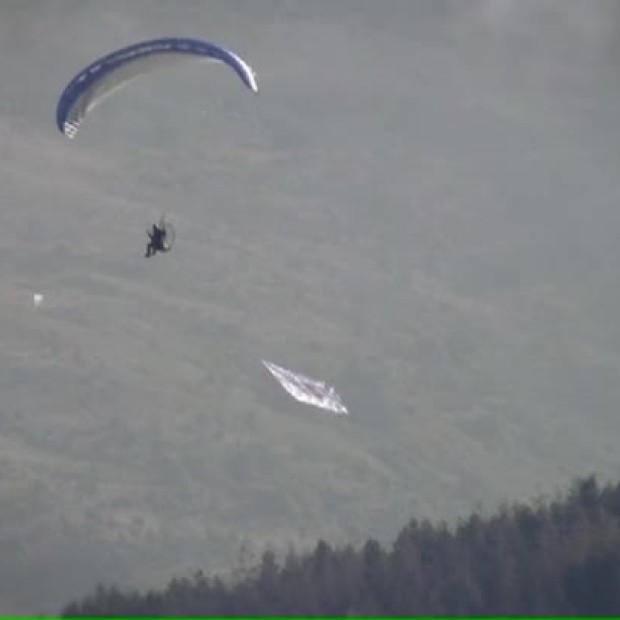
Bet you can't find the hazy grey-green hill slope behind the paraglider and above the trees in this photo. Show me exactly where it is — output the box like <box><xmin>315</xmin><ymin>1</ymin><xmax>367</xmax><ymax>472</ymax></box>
<box><xmin>0</xmin><ymin>0</ymin><xmax>620</xmax><ymax>611</ymax></box>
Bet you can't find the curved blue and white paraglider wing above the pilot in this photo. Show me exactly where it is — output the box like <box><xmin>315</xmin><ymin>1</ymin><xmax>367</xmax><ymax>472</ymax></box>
<box><xmin>56</xmin><ymin>38</ymin><xmax>258</xmax><ymax>138</ymax></box>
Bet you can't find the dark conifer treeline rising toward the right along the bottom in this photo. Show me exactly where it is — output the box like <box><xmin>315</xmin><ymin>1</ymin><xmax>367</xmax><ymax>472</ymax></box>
<box><xmin>63</xmin><ymin>477</ymin><xmax>620</xmax><ymax>616</ymax></box>
